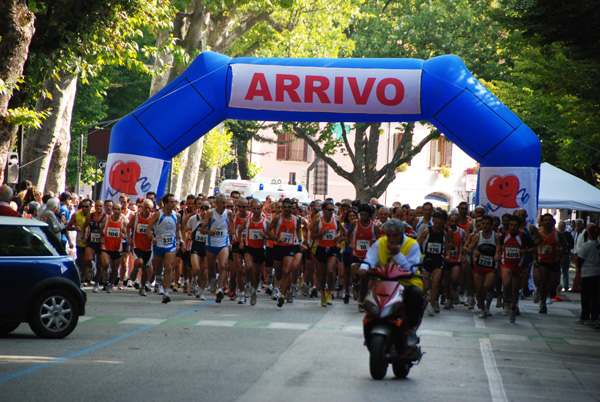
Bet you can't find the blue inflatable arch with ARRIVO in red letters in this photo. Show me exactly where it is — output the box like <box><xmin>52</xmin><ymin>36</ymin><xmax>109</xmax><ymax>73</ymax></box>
<box><xmin>104</xmin><ymin>52</ymin><xmax>541</xmax><ymax>214</ymax></box>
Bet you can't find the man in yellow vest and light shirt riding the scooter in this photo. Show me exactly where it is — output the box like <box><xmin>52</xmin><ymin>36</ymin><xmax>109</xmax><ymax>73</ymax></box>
<box><xmin>359</xmin><ymin>219</ymin><xmax>424</xmax><ymax>347</ymax></box>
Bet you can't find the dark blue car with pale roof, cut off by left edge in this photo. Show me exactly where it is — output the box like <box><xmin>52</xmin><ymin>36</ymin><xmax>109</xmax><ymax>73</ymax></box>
<box><xmin>0</xmin><ymin>217</ymin><xmax>86</xmax><ymax>338</ymax></box>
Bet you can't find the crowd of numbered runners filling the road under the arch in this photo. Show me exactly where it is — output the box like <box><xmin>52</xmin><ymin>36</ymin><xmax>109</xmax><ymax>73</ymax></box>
<box><xmin>63</xmin><ymin>192</ymin><xmax>569</xmax><ymax>322</ymax></box>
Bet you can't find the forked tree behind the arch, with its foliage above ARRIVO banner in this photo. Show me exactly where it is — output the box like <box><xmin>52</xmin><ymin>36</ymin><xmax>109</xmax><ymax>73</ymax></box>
<box><xmin>280</xmin><ymin>0</ymin><xmax>506</xmax><ymax>201</ymax></box>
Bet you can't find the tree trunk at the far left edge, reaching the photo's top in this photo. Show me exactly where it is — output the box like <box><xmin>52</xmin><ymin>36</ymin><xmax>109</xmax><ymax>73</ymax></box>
<box><xmin>0</xmin><ymin>0</ymin><xmax>35</xmax><ymax>183</ymax></box>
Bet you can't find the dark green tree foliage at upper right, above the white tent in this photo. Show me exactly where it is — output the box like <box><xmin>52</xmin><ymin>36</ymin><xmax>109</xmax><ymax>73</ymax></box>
<box><xmin>486</xmin><ymin>0</ymin><xmax>600</xmax><ymax>186</ymax></box>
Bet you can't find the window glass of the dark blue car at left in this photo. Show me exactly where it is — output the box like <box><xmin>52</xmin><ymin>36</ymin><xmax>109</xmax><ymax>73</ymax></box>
<box><xmin>0</xmin><ymin>225</ymin><xmax>66</xmax><ymax>257</ymax></box>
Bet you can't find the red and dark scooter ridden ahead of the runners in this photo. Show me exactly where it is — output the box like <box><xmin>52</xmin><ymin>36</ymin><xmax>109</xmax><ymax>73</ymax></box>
<box><xmin>363</xmin><ymin>263</ymin><xmax>423</xmax><ymax>380</ymax></box>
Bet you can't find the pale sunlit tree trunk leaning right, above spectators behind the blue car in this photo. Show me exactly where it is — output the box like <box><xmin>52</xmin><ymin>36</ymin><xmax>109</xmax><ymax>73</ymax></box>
<box><xmin>22</xmin><ymin>72</ymin><xmax>77</xmax><ymax>192</ymax></box>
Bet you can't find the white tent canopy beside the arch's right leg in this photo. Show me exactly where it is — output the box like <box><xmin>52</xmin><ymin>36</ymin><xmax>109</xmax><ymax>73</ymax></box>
<box><xmin>538</xmin><ymin>162</ymin><xmax>600</xmax><ymax>212</ymax></box>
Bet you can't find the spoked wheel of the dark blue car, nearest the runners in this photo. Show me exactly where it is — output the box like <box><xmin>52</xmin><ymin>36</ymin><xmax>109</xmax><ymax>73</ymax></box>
<box><xmin>29</xmin><ymin>290</ymin><xmax>79</xmax><ymax>339</ymax></box>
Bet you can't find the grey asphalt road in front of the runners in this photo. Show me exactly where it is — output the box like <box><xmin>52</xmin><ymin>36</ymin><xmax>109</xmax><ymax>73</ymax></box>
<box><xmin>0</xmin><ymin>289</ymin><xmax>600</xmax><ymax>402</ymax></box>
